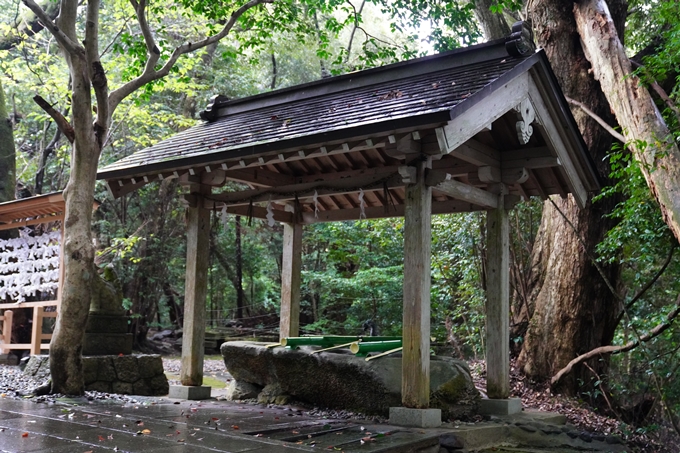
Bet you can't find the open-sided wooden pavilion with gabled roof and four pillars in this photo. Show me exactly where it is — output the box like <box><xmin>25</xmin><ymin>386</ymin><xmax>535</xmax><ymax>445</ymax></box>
<box><xmin>98</xmin><ymin>23</ymin><xmax>599</xmax><ymax>416</ymax></box>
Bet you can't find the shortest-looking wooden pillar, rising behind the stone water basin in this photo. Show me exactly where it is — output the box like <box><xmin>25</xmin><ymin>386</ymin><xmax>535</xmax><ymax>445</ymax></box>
<box><xmin>279</xmin><ymin>223</ymin><xmax>302</xmax><ymax>339</ymax></box>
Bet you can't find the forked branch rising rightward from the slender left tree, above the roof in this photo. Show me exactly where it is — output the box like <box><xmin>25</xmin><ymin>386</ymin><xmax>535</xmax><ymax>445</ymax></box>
<box><xmin>109</xmin><ymin>0</ymin><xmax>275</xmax><ymax>113</ymax></box>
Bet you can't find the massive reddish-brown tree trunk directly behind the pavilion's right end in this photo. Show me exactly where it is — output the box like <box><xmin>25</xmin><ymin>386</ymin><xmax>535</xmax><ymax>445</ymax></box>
<box><xmin>519</xmin><ymin>0</ymin><xmax>620</xmax><ymax>393</ymax></box>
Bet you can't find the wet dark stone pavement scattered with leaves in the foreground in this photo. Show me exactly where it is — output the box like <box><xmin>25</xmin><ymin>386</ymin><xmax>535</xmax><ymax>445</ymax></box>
<box><xmin>0</xmin><ymin>398</ymin><xmax>441</xmax><ymax>453</ymax></box>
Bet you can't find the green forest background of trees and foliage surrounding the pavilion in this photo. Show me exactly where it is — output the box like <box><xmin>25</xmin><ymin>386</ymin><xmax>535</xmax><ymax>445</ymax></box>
<box><xmin>0</xmin><ymin>0</ymin><xmax>680</xmax><ymax>442</ymax></box>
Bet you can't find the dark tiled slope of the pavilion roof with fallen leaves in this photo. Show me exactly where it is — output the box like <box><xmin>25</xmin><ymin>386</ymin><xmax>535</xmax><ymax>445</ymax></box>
<box><xmin>98</xmin><ymin>46</ymin><xmax>524</xmax><ymax>179</ymax></box>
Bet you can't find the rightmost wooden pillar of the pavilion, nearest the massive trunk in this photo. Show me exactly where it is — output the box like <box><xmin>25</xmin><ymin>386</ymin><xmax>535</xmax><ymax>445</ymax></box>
<box><xmin>486</xmin><ymin>194</ymin><xmax>510</xmax><ymax>399</ymax></box>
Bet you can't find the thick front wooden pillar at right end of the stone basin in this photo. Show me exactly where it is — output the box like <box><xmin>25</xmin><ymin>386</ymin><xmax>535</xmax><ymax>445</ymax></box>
<box><xmin>401</xmin><ymin>159</ymin><xmax>432</xmax><ymax>409</ymax></box>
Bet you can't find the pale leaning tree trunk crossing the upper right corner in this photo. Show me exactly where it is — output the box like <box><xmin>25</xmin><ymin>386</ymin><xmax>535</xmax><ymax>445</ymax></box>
<box><xmin>574</xmin><ymin>0</ymin><xmax>680</xmax><ymax>245</ymax></box>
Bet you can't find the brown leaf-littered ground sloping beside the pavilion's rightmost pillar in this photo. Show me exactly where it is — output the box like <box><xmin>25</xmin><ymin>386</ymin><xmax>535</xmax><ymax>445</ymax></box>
<box><xmin>468</xmin><ymin>360</ymin><xmax>680</xmax><ymax>453</ymax></box>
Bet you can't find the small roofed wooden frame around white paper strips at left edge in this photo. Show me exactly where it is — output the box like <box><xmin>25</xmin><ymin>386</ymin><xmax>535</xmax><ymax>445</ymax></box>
<box><xmin>0</xmin><ymin>192</ymin><xmax>65</xmax><ymax>354</ymax></box>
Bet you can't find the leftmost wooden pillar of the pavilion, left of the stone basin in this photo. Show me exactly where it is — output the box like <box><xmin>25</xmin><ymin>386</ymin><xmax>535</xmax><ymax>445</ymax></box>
<box><xmin>180</xmin><ymin>194</ymin><xmax>210</xmax><ymax>386</ymax></box>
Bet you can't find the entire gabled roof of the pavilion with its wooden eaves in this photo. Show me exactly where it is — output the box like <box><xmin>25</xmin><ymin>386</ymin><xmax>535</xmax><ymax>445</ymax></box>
<box><xmin>98</xmin><ymin>33</ymin><xmax>599</xmax><ymax>217</ymax></box>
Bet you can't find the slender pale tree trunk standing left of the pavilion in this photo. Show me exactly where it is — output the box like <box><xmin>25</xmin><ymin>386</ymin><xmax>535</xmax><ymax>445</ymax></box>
<box><xmin>50</xmin><ymin>0</ymin><xmax>104</xmax><ymax>395</ymax></box>
